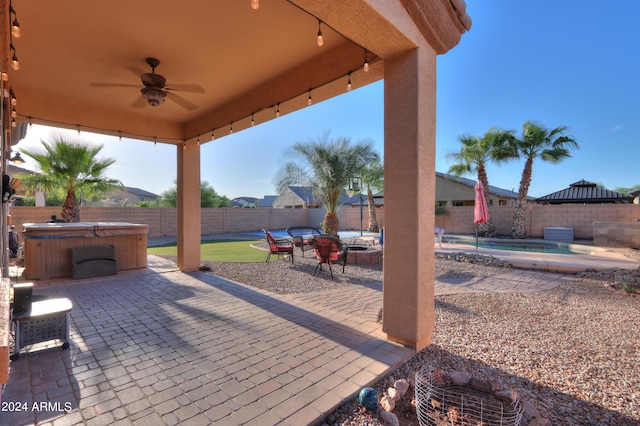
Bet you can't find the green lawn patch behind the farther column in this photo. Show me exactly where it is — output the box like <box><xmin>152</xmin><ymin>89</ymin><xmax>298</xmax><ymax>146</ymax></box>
<box><xmin>147</xmin><ymin>240</ymin><xmax>267</xmax><ymax>262</ymax></box>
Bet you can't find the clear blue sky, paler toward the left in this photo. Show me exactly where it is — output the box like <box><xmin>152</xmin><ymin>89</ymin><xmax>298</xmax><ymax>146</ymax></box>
<box><xmin>18</xmin><ymin>0</ymin><xmax>640</xmax><ymax>198</ymax></box>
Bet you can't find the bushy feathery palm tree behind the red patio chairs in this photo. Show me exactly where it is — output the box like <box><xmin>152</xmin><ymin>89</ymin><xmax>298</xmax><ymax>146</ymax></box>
<box><xmin>275</xmin><ymin>133</ymin><xmax>379</xmax><ymax>235</ymax></box>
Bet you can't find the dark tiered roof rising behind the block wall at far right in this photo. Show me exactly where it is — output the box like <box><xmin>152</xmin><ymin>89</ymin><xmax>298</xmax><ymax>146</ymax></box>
<box><xmin>536</xmin><ymin>179</ymin><xmax>634</xmax><ymax>204</ymax></box>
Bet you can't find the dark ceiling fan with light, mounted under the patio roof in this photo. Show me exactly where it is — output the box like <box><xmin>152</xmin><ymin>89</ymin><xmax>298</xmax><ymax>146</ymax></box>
<box><xmin>91</xmin><ymin>58</ymin><xmax>204</xmax><ymax>110</ymax></box>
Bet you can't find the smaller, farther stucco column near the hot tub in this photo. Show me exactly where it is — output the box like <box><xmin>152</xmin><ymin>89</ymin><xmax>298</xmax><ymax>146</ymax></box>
<box><xmin>177</xmin><ymin>144</ymin><xmax>201</xmax><ymax>272</ymax></box>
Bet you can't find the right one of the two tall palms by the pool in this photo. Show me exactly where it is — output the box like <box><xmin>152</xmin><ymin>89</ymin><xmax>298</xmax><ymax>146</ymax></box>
<box><xmin>511</xmin><ymin>121</ymin><xmax>578</xmax><ymax>238</ymax></box>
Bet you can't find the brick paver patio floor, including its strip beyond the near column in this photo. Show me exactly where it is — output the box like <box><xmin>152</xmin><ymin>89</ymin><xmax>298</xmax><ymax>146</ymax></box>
<box><xmin>0</xmin><ymin>258</ymin><xmax>570</xmax><ymax>426</ymax></box>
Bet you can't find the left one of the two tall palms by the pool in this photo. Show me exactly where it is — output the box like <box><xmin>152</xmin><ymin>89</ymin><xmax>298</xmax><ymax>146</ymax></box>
<box><xmin>447</xmin><ymin>128</ymin><xmax>513</xmax><ymax>238</ymax></box>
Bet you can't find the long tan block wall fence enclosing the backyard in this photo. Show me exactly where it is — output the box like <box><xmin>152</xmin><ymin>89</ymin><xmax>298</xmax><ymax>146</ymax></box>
<box><xmin>9</xmin><ymin>204</ymin><xmax>640</xmax><ymax>246</ymax></box>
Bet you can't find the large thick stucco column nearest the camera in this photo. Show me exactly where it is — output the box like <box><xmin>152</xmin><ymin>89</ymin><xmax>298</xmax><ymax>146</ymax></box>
<box><xmin>382</xmin><ymin>46</ymin><xmax>436</xmax><ymax>351</ymax></box>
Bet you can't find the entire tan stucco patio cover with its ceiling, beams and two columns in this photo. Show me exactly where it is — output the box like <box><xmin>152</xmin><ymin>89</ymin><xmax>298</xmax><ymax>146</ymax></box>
<box><xmin>0</xmin><ymin>0</ymin><xmax>471</xmax><ymax>350</ymax></box>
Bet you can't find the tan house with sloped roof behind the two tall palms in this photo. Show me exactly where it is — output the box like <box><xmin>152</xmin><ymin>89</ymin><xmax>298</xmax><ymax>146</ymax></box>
<box><xmin>436</xmin><ymin>172</ymin><xmax>535</xmax><ymax>206</ymax></box>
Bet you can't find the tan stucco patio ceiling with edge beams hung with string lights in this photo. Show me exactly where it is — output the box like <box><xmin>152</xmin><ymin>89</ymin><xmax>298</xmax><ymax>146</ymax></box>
<box><xmin>5</xmin><ymin>0</ymin><xmax>382</xmax><ymax>143</ymax></box>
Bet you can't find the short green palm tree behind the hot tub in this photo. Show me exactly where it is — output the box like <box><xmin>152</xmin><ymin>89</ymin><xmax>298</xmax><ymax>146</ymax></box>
<box><xmin>20</xmin><ymin>132</ymin><xmax>122</xmax><ymax>222</ymax></box>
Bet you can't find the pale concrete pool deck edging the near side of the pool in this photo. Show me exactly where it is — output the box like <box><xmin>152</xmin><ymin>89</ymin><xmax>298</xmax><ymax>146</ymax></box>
<box><xmin>436</xmin><ymin>241</ymin><xmax>640</xmax><ymax>274</ymax></box>
